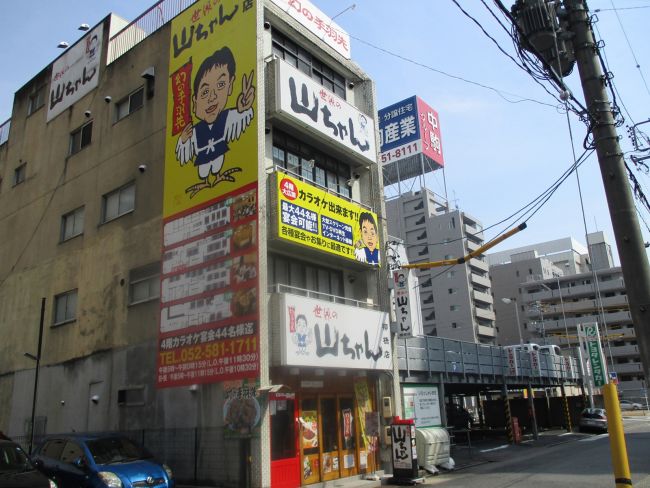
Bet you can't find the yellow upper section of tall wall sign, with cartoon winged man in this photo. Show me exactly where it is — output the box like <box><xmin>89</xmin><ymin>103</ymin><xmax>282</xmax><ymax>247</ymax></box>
<box><xmin>163</xmin><ymin>0</ymin><xmax>259</xmax><ymax>218</ymax></box>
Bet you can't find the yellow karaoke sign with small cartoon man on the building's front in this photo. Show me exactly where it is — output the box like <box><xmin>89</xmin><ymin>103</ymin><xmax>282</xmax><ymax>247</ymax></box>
<box><xmin>277</xmin><ymin>172</ymin><xmax>380</xmax><ymax>266</ymax></box>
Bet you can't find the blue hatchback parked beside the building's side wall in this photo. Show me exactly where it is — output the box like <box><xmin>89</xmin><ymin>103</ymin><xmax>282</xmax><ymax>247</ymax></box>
<box><xmin>32</xmin><ymin>435</ymin><xmax>174</xmax><ymax>488</ymax></box>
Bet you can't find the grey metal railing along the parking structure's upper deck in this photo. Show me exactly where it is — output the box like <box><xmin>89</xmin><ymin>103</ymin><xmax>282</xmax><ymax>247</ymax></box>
<box><xmin>397</xmin><ymin>336</ymin><xmax>580</xmax><ymax>383</ymax></box>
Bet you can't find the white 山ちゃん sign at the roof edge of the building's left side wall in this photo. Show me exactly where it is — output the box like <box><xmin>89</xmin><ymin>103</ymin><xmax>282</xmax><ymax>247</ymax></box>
<box><xmin>46</xmin><ymin>24</ymin><xmax>104</xmax><ymax>122</ymax></box>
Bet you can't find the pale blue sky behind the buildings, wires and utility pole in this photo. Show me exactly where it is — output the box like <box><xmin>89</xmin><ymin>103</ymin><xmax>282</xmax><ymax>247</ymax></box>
<box><xmin>0</xmin><ymin>0</ymin><xmax>650</xmax><ymax>263</ymax></box>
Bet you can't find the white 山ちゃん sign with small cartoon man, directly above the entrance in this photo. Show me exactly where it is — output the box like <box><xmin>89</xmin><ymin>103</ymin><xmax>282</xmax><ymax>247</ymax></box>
<box><xmin>280</xmin><ymin>294</ymin><xmax>392</xmax><ymax>370</ymax></box>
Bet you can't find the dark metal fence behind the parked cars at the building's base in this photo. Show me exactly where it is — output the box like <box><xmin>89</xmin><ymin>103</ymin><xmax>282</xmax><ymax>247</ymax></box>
<box><xmin>13</xmin><ymin>427</ymin><xmax>251</xmax><ymax>488</ymax></box>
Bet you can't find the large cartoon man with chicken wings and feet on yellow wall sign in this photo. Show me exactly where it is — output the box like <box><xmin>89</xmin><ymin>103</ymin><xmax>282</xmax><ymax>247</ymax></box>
<box><xmin>176</xmin><ymin>47</ymin><xmax>255</xmax><ymax>198</ymax></box>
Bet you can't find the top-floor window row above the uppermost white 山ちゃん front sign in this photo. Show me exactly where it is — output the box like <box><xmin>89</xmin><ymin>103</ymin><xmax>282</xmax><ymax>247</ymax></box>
<box><xmin>271</xmin><ymin>29</ymin><xmax>346</xmax><ymax>100</ymax></box>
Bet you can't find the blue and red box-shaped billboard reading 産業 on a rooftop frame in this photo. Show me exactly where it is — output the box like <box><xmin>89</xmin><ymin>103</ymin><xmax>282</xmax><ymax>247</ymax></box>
<box><xmin>378</xmin><ymin>96</ymin><xmax>445</xmax><ymax>166</ymax></box>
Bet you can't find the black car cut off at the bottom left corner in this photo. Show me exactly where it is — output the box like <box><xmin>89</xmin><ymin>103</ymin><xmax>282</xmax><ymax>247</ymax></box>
<box><xmin>0</xmin><ymin>439</ymin><xmax>57</xmax><ymax>488</ymax></box>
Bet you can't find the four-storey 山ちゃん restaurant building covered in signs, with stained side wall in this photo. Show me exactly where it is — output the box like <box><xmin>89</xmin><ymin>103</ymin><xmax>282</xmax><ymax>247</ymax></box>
<box><xmin>0</xmin><ymin>0</ymin><xmax>400</xmax><ymax>486</ymax></box>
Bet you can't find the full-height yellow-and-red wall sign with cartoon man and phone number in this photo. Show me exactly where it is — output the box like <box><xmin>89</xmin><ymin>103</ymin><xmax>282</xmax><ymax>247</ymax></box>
<box><xmin>157</xmin><ymin>0</ymin><xmax>259</xmax><ymax>388</ymax></box>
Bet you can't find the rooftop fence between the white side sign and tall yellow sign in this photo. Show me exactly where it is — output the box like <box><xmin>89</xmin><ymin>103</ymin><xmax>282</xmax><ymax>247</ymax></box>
<box><xmin>106</xmin><ymin>0</ymin><xmax>196</xmax><ymax>64</ymax></box>
